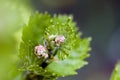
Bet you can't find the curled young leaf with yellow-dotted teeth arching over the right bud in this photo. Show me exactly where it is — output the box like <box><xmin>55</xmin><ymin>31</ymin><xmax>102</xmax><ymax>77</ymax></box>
<box><xmin>46</xmin><ymin>15</ymin><xmax>77</xmax><ymax>59</ymax></box>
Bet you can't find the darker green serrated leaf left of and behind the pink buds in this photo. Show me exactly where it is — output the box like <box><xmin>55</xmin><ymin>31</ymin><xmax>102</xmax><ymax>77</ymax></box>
<box><xmin>20</xmin><ymin>13</ymin><xmax>50</xmax><ymax>66</ymax></box>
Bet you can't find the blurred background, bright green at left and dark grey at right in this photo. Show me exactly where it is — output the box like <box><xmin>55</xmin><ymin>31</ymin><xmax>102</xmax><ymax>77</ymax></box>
<box><xmin>0</xmin><ymin>0</ymin><xmax>120</xmax><ymax>80</ymax></box>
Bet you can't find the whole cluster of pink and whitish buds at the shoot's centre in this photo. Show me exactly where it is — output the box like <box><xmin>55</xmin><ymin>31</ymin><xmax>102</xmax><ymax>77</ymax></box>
<box><xmin>34</xmin><ymin>35</ymin><xmax>65</xmax><ymax>59</ymax></box>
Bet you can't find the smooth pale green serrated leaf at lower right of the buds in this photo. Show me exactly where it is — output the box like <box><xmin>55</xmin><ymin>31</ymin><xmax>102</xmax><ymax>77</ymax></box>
<box><xmin>47</xmin><ymin>38</ymin><xmax>91</xmax><ymax>76</ymax></box>
